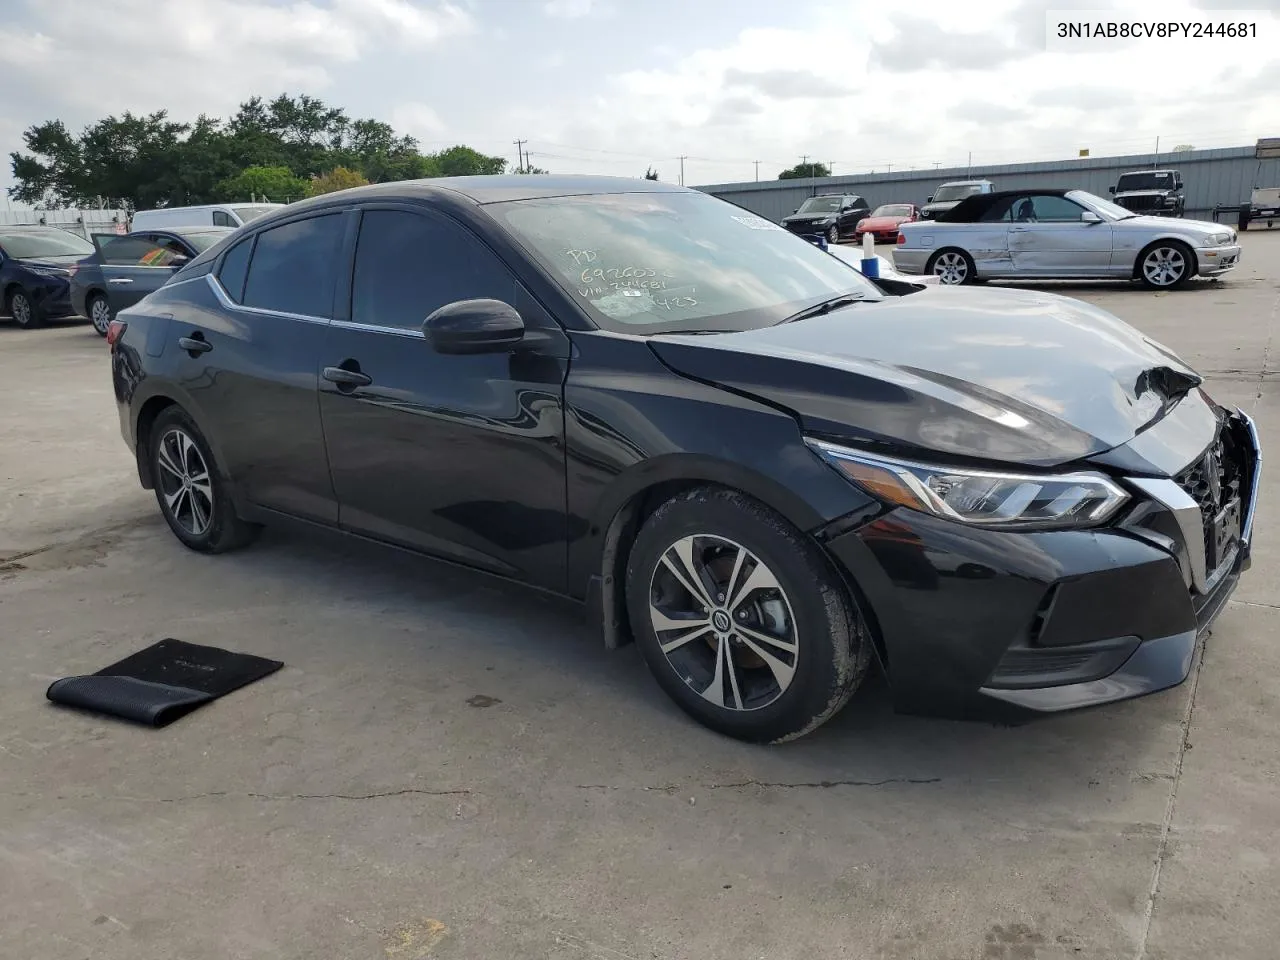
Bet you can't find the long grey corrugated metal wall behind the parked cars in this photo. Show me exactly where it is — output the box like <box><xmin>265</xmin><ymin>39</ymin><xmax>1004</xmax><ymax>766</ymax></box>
<box><xmin>696</xmin><ymin>147</ymin><xmax>1280</xmax><ymax>223</ymax></box>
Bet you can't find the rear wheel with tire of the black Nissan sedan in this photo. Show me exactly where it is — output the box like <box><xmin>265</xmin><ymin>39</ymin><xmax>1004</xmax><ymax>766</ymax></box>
<box><xmin>150</xmin><ymin>407</ymin><xmax>260</xmax><ymax>553</ymax></box>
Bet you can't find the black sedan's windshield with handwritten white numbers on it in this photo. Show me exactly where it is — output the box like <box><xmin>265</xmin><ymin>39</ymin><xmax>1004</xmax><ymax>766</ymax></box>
<box><xmin>486</xmin><ymin>192</ymin><xmax>879</xmax><ymax>334</ymax></box>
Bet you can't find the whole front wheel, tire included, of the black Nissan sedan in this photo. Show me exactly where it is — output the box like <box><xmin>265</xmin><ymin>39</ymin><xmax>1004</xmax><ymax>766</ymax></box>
<box><xmin>626</xmin><ymin>488</ymin><xmax>872</xmax><ymax>742</ymax></box>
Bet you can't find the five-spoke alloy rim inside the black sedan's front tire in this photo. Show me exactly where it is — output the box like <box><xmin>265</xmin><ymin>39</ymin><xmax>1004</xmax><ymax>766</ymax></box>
<box><xmin>649</xmin><ymin>534</ymin><xmax>800</xmax><ymax>710</ymax></box>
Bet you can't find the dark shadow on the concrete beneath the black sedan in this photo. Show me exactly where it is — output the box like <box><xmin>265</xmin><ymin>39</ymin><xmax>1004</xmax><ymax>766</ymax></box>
<box><xmin>222</xmin><ymin>519</ymin><xmax>1185</xmax><ymax>815</ymax></box>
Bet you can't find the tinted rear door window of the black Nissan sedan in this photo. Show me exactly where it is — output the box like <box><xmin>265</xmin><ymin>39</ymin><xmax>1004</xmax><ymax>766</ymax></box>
<box><xmin>242</xmin><ymin>212</ymin><xmax>345</xmax><ymax>320</ymax></box>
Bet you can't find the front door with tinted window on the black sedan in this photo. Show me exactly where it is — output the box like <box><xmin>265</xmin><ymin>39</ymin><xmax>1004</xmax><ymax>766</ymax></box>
<box><xmin>320</xmin><ymin>205</ymin><xmax>570</xmax><ymax>590</ymax></box>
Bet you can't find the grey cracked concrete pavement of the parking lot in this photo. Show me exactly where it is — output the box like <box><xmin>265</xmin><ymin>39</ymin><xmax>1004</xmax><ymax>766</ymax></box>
<box><xmin>0</xmin><ymin>232</ymin><xmax>1280</xmax><ymax>960</ymax></box>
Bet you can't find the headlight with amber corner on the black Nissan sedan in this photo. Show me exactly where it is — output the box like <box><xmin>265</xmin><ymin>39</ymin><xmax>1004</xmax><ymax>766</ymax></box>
<box><xmin>805</xmin><ymin>439</ymin><xmax>1129</xmax><ymax>530</ymax></box>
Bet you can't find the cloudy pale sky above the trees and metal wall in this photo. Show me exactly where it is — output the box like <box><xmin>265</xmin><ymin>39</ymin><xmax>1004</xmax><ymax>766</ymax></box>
<box><xmin>0</xmin><ymin>0</ymin><xmax>1280</xmax><ymax>195</ymax></box>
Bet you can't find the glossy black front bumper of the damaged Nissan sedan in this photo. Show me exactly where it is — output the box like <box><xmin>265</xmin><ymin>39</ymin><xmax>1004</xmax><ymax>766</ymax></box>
<box><xmin>819</xmin><ymin>413</ymin><xmax>1261</xmax><ymax>718</ymax></box>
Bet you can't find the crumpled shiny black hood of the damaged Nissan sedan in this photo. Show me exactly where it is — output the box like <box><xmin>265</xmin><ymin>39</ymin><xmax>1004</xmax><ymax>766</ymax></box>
<box><xmin>649</xmin><ymin>288</ymin><xmax>1201</xmax><ymax>466</ymax></box>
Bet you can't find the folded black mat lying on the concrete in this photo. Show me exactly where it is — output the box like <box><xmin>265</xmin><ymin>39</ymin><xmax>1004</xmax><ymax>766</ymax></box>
<box><xmin>46</xmin><ymin>640</ymin><xmax>284</xmax><ymax>727</ymax></box>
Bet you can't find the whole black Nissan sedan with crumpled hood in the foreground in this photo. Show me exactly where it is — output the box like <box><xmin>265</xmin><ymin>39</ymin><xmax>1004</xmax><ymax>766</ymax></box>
<box><xmin>109</xmin><ymin>177</ymin><xmax>1261</xmax><ymax>741</ymax></box>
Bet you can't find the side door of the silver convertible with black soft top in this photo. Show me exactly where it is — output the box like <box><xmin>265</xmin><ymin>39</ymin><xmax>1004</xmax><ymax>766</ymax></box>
<box><xmin>1009</xmin><ymin>193</ymin><xmax>1112</xmax><ymax>276</ymax></box>
